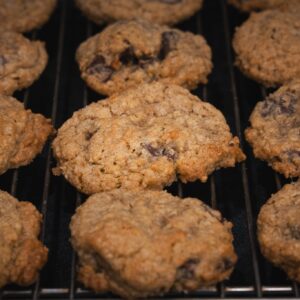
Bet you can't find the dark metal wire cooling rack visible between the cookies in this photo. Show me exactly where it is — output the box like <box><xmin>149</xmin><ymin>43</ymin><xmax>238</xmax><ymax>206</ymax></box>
<box><xmin>0</xmin><ymin>0</ymin><xmax>299</xmax><ymax>300</ymax></box>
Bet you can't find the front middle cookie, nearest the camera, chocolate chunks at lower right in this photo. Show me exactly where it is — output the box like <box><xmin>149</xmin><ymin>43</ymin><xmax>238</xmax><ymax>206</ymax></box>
<box><xmin>71</xmin><ymin>190</ymin><xmax>236</xmax><ymax>298</ymax></box>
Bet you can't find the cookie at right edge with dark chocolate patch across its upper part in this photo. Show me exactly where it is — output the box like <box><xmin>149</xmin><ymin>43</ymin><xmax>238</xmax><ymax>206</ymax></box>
<box><xmin>245</xmin><ymin>79</ymin><xmax>300</xmax><ymax>177</ymax></box>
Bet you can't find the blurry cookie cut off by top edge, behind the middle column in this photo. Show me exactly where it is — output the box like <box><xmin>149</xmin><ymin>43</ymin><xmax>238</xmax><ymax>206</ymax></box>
<box><xmin>76</xmin><ymin>0</ymin><xmax>203</xmax><ymax>25</ymax></box>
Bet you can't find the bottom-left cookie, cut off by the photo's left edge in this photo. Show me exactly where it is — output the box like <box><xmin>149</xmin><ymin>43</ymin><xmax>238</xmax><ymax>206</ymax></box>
<box><xmin>0</xmin><ymin>191</ymin><xmax>48</xmax><ymax>288</ymax></box>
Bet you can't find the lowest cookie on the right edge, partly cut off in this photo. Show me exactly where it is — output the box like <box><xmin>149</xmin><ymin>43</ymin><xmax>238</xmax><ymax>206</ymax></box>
<box><xmin>257</xmin><ymin>180</ymin><xmax>300</xmax><ymax>282</ymax></box>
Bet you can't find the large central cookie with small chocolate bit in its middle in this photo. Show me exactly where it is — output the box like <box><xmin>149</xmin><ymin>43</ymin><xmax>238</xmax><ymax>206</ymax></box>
<box><xmin>53</xmin><ymin>82</ymin><xmax>245</xmax><ymax>194</ymax></box>
